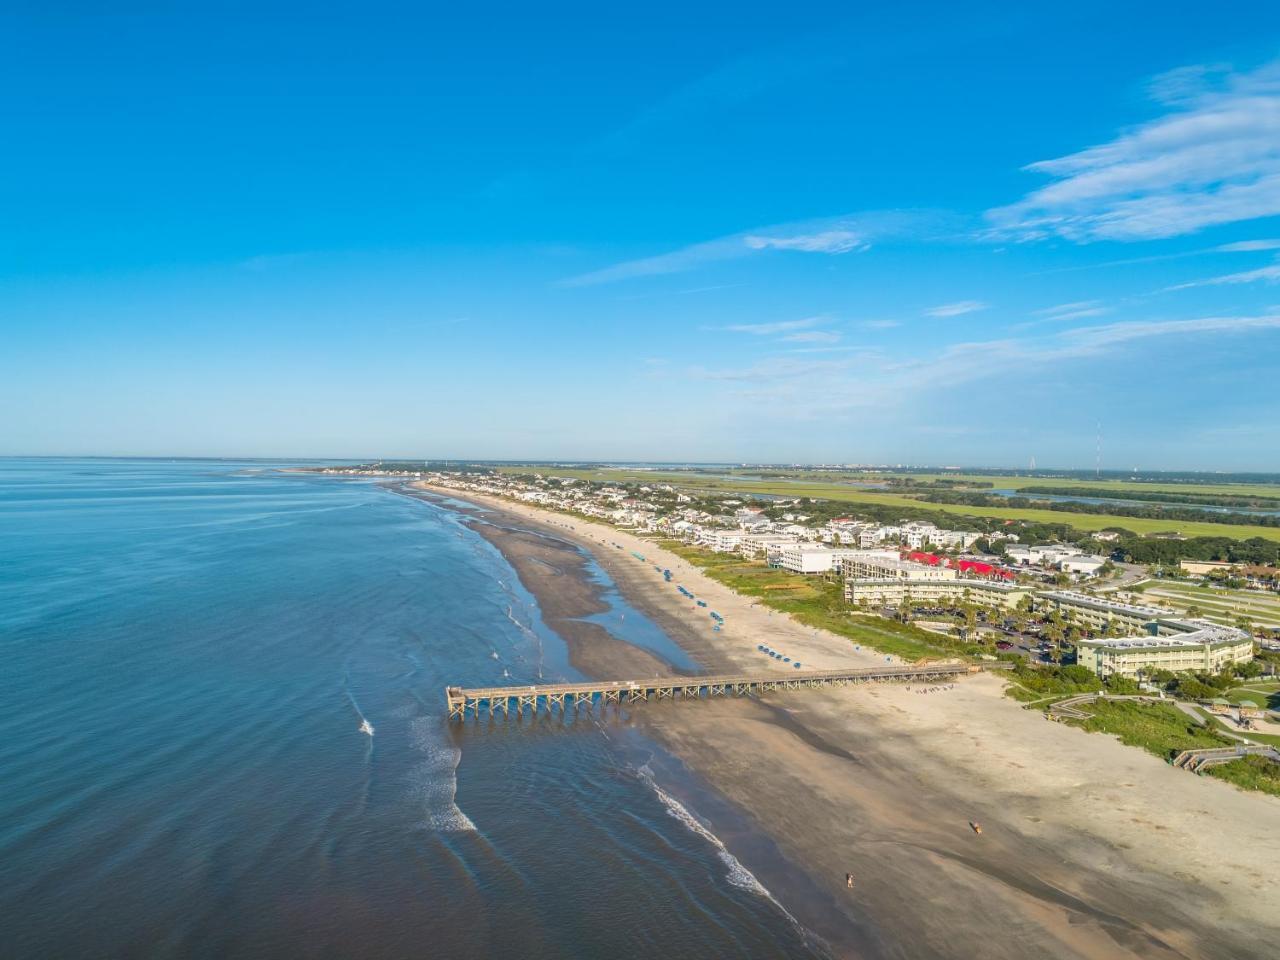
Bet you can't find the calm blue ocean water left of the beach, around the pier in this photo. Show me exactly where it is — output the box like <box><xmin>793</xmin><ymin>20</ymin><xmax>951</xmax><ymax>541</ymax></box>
<box><xmin>0</xmin><ymin>460</ymin><xmax>809</xmax><ymax>960</ymax></box>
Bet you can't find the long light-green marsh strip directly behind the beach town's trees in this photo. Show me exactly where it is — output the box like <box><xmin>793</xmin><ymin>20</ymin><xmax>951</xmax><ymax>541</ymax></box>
<box><xmin>499</xmin><ymin>466</ymin><xmax>1280</xmax><ymax>541</ymax></box>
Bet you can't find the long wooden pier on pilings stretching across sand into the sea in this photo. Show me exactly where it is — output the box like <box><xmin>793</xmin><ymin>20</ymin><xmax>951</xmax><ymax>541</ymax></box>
<box><xmin>444</xmin><ymin>663</ymin><xmax>988</xmax><ymax>721</ymax></box>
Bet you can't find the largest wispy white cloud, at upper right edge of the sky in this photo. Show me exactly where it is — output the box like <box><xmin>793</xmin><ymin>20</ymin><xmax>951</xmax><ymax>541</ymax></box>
<box><xmin>988</xmin><ymin>63</ymin><xmax>1280</xmax><ymax>242</ymax></box>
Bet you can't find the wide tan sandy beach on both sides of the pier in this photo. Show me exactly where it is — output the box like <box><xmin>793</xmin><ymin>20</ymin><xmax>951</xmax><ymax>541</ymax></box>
<box><xmin>424</xmin><ymin>486</ymin><xmax>1280</xmax><ymax>960</ymax></box>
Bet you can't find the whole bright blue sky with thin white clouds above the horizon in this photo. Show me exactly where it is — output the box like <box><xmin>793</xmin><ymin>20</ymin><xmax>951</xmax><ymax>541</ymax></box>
<box><xmin>0</xmin><ymin>0</ymin><xmax>1280</xmax><ymax>471</ymax></box>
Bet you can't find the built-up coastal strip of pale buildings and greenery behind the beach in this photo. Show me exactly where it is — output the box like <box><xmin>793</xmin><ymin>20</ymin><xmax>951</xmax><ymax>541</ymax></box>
<box><xmin>314</xmin><ymin>465</ymin><xmax>1280</xmax><ymax>792</ymax></box>
